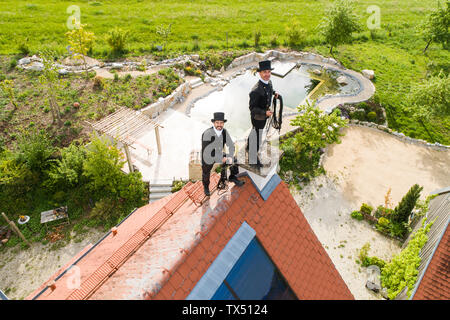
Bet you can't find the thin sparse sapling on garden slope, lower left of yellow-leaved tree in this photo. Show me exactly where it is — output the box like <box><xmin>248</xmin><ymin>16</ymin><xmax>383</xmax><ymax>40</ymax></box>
<box><xmin>39</xmin><ymin>50</ymin><xmax>62</xmax><ymax>126</ymax></box>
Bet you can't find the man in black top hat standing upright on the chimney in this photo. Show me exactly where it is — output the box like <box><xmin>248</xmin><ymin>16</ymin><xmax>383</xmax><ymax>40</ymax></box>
<box><xmin>247</xmin><ymin>60</ymin><xmax>278</xmax><ymax>166</ymax></box>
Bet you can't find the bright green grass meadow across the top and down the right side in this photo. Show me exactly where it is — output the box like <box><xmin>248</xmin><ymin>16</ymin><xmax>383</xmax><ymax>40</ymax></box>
<box><xmin>0</xmin><ymin>0</ymin><xmax>450</xmax><ymax>144</ymax></box>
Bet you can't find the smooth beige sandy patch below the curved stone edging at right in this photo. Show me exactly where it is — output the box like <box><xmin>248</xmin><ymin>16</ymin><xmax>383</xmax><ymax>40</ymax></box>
<box><xmin>323</xmin><ymin>126</ymin><xmax>450</xmax><ymax>206</ymax></box>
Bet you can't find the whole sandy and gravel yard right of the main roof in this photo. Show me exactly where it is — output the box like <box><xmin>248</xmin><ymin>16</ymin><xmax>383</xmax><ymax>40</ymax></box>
<box><xmin>293</xmin><ymin>127</ymin><xmax>450</xmax><ymax>300</ymax></box>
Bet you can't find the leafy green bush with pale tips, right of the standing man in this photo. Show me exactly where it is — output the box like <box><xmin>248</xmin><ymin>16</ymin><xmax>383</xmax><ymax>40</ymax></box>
<box><xmin>280</xmin><ymin>102</ymin><xmax>347</xmax><ymax>186</ymax></box>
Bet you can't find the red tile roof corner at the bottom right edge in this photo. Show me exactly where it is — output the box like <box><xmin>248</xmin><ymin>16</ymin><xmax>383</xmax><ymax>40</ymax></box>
<box><xmin>413</xmin><ymin>226</ymin><xmax>450</xmax><ymax>300</ymax></box>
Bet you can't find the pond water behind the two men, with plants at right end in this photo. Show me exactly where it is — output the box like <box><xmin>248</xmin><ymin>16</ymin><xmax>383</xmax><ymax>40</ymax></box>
<box><xmin>190</xmin><ymin>64</ymin><xmax>359</xmax><ymax>139</ymax></box>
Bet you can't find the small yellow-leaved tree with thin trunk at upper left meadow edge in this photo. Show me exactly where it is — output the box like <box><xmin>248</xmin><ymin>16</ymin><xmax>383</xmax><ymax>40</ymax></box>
<box><xmin>66</xmin><ymin>21</ymin><xmax>95</xmax><ymax>79</ymax></box>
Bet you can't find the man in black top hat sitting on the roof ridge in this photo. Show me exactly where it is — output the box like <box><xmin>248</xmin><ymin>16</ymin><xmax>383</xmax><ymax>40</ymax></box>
<box><xmin>202</xmin><ymin>112</ymin><xmax>244</xmax><ymax>196</ymax></box>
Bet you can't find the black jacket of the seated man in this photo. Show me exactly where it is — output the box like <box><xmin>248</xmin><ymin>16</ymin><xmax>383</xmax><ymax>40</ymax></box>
<box><xmin>202</xmin><ymin>127</ymin><xmax>234</xmax><ymax>165</ymax></box>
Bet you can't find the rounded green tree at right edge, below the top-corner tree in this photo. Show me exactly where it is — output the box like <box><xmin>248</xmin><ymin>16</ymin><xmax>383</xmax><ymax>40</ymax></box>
<box><xmin>407</xmin><ymin>70</ymin><xmax>450</xmax><ymax>124</ymax></box>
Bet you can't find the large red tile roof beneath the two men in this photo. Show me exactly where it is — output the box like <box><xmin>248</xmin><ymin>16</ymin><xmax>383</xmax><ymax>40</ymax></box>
<box><xmin>29</xmin><ymin>173</ymin><xmax>353</xmax><ymax>299</ymax></box>
